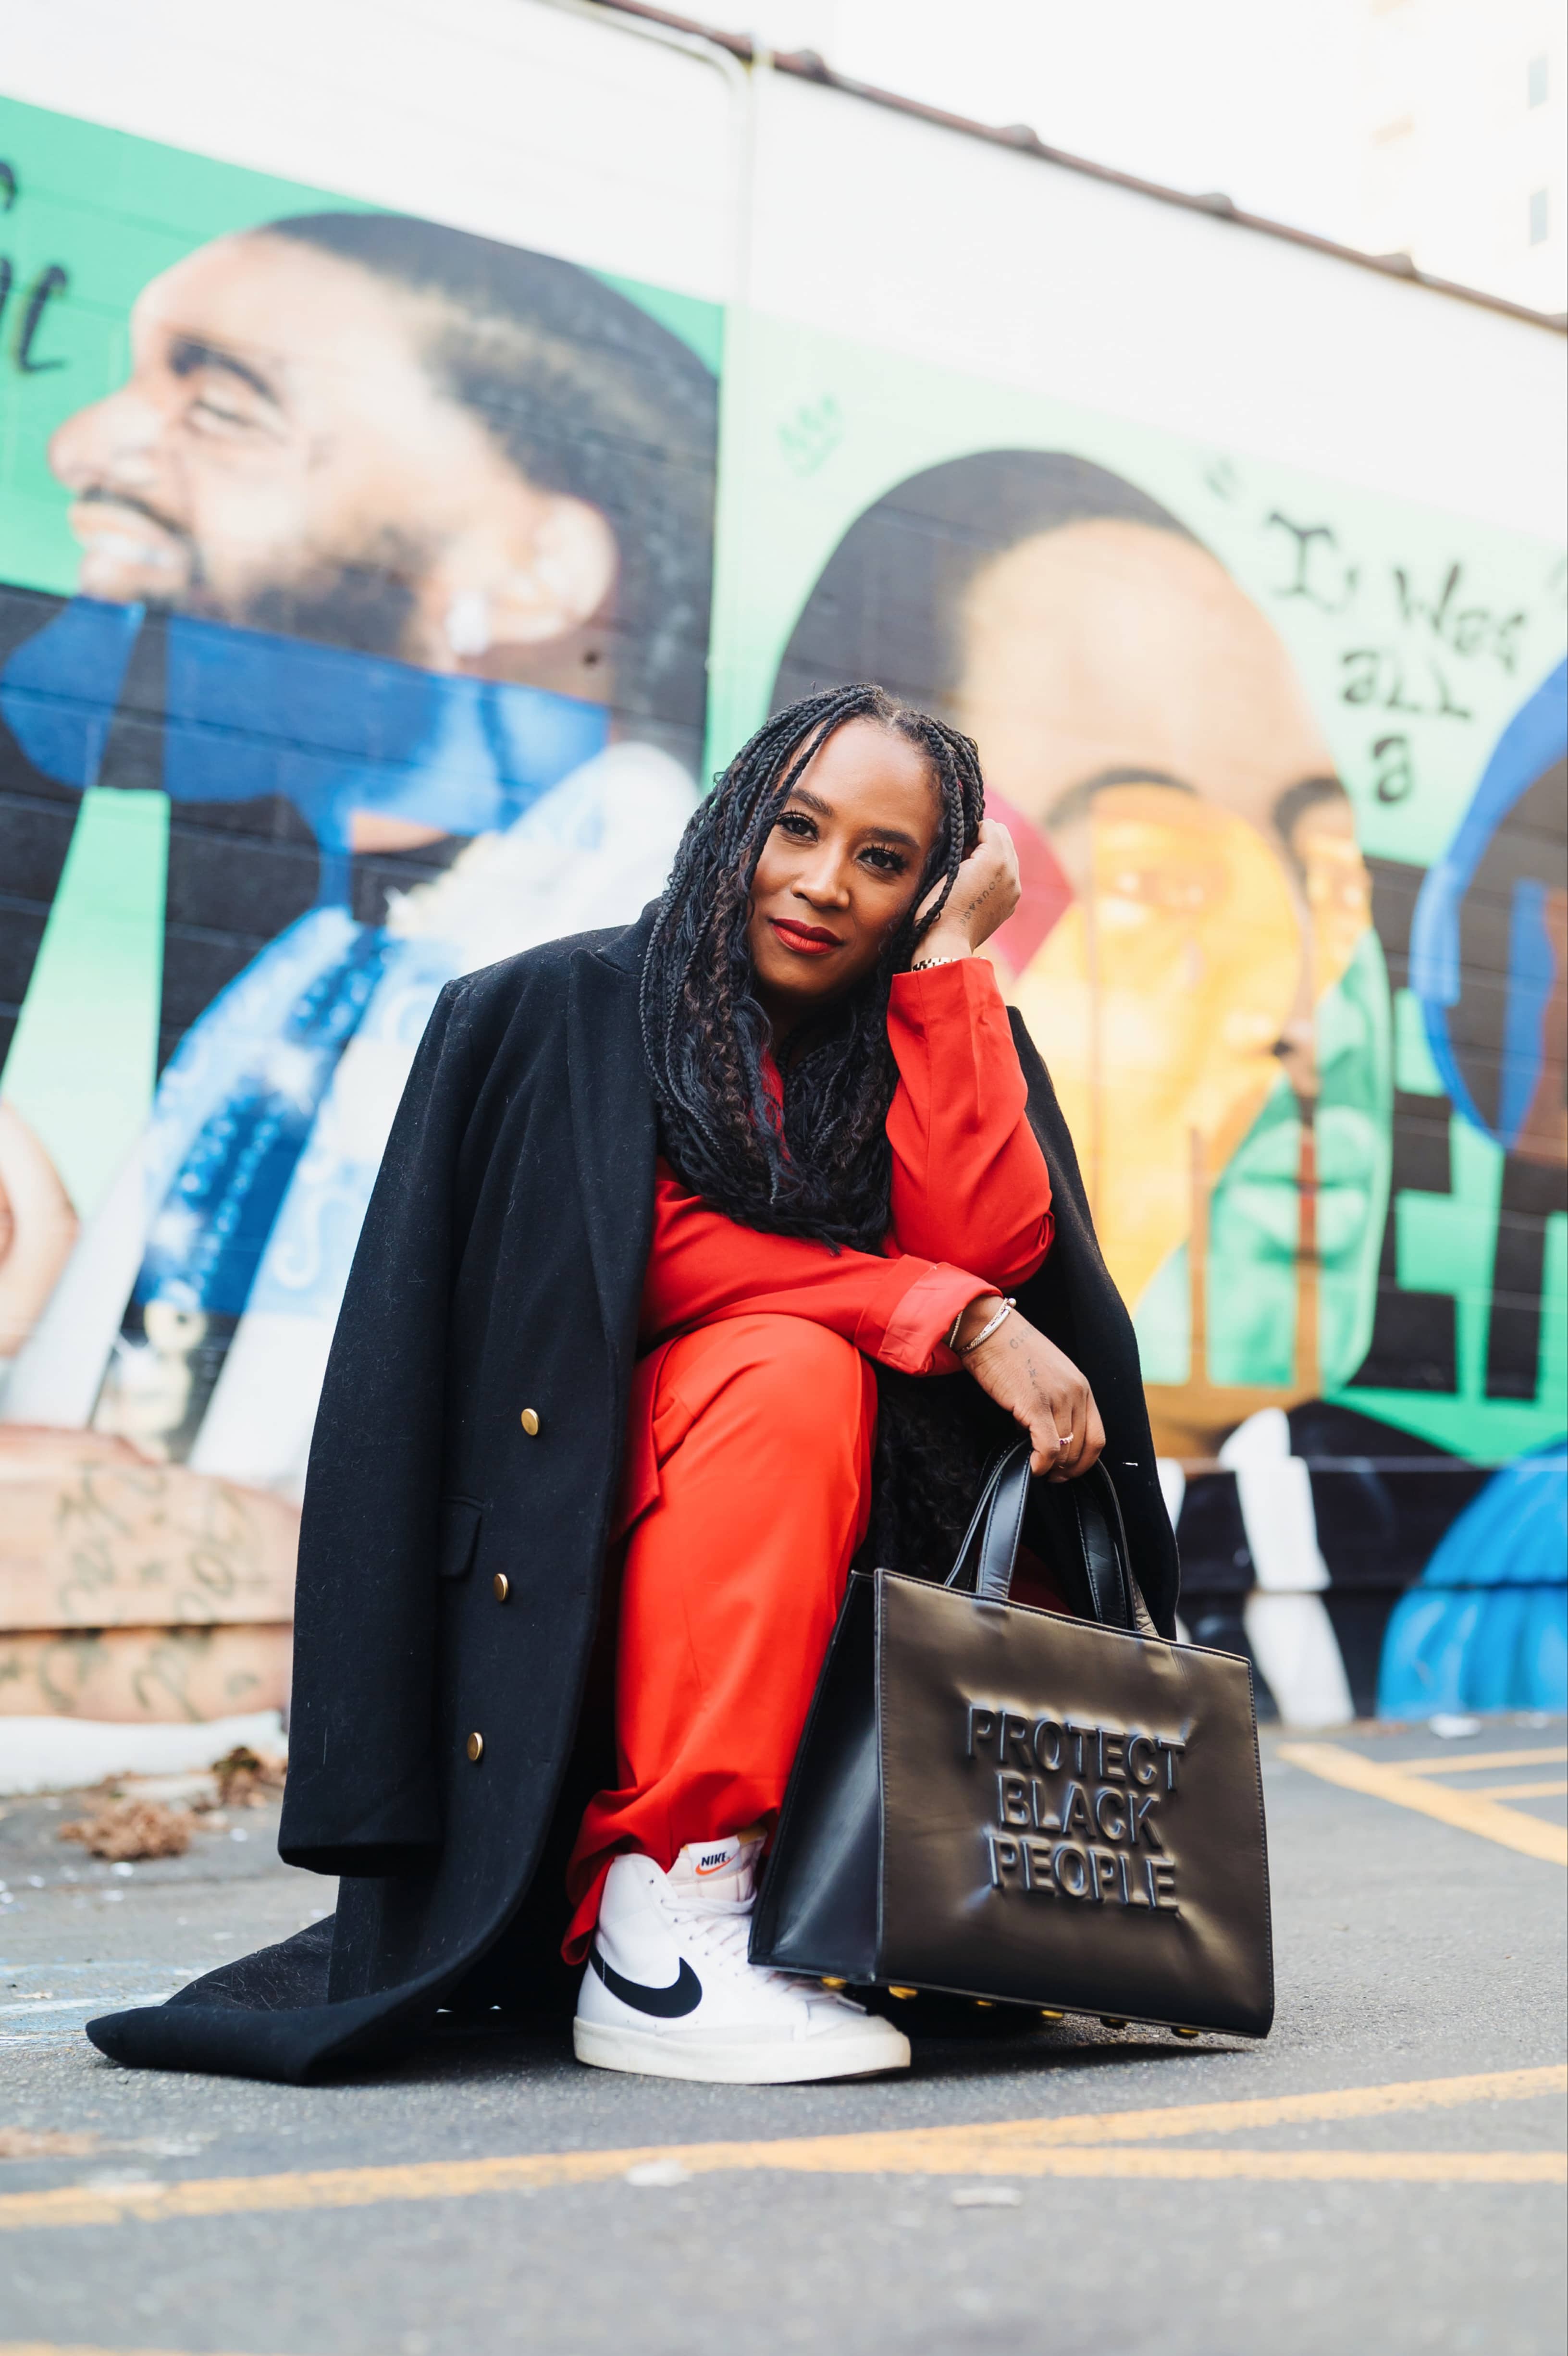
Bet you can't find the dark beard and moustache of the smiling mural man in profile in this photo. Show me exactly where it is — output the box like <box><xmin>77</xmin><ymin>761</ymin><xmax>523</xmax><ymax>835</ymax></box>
<box><xmin>78</xmin><ymin>490</ymin><xmax>431</xmax><ymax>662</ymax></box>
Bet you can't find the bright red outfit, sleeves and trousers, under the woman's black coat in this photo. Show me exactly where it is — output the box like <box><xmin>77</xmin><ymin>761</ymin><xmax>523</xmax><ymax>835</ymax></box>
<box><xmin>563</xmin><ymin>957</ymin><xmax>1052</xmax><ymax>1962</ymax></box>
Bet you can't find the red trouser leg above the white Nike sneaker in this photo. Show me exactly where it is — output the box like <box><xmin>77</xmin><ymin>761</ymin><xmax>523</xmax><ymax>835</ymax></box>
<box><xmin>563</xmin><ymin>1317</ymin><xmax>876</xmax><ymax>1962</ymax></box>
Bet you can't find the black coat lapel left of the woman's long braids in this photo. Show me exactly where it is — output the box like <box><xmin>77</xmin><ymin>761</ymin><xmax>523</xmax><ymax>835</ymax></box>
<box><xmin>568</xmin><ymin>916</ymin><xmax>657</xmax><ymax>1359</ymax></box>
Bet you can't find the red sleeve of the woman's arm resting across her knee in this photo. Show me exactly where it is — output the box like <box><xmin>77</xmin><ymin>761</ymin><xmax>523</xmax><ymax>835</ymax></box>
<box><xmin>641</xmin><ymin>1161</ymin><xmax>989</xmax><ymax>1373</ymax></box>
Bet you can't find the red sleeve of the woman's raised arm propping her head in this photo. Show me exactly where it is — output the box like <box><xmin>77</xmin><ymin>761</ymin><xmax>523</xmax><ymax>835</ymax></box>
<box><xmin>888</xmin><ymin>957</ymin><xmax>1052</xmax><ymax>1291</ymax></box>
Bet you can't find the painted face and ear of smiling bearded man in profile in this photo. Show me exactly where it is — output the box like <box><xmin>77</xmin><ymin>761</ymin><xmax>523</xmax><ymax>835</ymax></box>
<box><xmin>49</xmin><ymin>231</ymin><xmax>617</xmax><ymax>700</ymax></box>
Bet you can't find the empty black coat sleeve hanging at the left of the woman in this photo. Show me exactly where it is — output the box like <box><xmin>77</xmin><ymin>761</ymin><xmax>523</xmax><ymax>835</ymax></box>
<box><xmin>278</xmin><ymin>983</ymin><xmax>473</xmax><ymax>1873</ymax></box>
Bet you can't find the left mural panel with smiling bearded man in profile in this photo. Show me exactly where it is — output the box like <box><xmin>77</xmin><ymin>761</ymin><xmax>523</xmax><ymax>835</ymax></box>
<box><xmin>0</xmin><ymin>109</ymin><xmax>718</xmax><ymax>1717</ymax></box>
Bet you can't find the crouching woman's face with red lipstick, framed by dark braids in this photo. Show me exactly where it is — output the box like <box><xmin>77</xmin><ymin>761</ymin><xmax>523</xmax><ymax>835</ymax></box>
<box><xmin>746</xmin><ymin>718</ymin><xmax>942</xmax><ymax>1039</ymax></box>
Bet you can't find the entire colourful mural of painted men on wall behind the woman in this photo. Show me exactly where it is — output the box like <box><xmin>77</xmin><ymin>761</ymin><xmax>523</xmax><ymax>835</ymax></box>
<box><xmin>0</xmin><ymin>92</ymin><xmax>1568</xmax><ymax>1722</ymax></box>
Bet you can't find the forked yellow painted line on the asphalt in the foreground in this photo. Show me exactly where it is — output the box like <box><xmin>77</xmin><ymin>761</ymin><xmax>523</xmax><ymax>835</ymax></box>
<box><xmin>0</xmin><ymin>2064</ymin><xmax>1568</xmax><ymax>2231</ymax></box>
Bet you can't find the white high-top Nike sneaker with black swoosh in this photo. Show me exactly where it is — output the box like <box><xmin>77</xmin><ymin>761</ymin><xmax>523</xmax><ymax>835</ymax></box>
<box><xmin>572</xmin><ymin>1835</ymin><xmax>909</xmax><ymax>2085</ymax></box>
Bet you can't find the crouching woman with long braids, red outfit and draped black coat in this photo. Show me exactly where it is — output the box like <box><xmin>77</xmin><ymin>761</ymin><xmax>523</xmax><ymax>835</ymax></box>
<box><xmin>89</xmin><ymin>686</ymin><xmax>1175</xmax><ymax>2078</ymax></box>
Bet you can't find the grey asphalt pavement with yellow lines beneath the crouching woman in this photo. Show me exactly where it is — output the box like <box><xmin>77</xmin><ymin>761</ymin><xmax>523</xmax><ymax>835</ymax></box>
<box><xmin>0</xmin><ymin>1717</ymin><xmax>1568</xmax><ymax>2356</ymax></box>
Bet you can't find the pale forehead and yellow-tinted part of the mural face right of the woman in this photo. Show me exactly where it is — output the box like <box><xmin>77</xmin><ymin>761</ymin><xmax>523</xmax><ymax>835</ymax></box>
<box><xmin>956</xmin><ymin>518</ymin><xmax>1368</xmax><ymax>1300</ymax></box>
